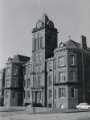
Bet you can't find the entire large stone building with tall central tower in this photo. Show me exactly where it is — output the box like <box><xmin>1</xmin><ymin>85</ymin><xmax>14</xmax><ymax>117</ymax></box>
<box><xmin>0</xmin><ymin>14</ymin><xmax>90</xmax><ymax>109</ymax></box>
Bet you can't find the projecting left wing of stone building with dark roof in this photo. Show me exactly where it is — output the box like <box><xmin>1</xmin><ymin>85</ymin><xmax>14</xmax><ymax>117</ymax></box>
<box><xmin>4</xmin><ymin>55</ymin><xmax>29</xmax><ymax>106</ymax></box>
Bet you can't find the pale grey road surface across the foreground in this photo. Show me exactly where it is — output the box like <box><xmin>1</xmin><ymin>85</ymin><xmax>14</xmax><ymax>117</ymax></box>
<box><xmin>0</xmin><ymin>111</ymin><xmax>90</xmax><ymax>120</ymax></box>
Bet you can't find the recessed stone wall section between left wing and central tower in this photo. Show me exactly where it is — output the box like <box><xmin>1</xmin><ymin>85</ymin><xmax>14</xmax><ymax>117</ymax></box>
<box><xmin>24</xmin><ymin>59</ymin><xmax>33</xmax><ymax>105</ymax></box>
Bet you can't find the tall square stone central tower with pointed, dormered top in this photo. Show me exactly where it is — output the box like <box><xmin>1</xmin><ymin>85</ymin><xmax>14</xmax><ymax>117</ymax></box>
<box><xmin>32</xmin><ymin>14</ymin><xmax>57</xmax><ymax>106</ymax></box>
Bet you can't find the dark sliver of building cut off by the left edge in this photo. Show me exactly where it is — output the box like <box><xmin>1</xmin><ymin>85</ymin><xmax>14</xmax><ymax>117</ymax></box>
<box><xmin>0</xmin><ymin>69</ymin><xmax>5</xmax><ymax>106</ymax></box>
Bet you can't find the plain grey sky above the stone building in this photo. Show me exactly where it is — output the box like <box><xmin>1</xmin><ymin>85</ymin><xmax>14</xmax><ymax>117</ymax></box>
<box><xmin>0</xmin><ymin>0</ymin><xmax>90</xmax><ymax>68</ymax></box>
